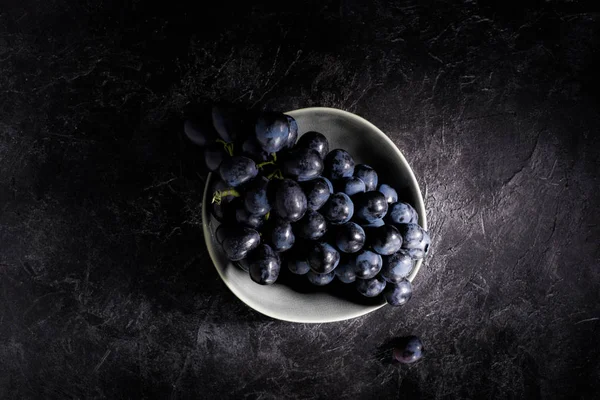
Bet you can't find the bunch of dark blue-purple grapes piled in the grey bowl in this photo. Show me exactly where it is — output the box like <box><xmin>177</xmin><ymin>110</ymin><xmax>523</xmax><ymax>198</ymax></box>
<box><xmin>184</xmin><ymin>107</ymin><xmax>430</xmax><ymax>306</ymax></box>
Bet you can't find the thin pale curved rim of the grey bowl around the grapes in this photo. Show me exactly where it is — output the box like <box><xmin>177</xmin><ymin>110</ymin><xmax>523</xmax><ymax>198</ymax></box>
<box><xmin>202</xmin><ymin>107</ymin><xmax>427</xmax><ymax>323</ymax></box>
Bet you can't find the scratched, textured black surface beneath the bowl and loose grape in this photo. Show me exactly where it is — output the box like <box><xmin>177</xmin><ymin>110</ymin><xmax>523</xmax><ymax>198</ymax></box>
<box><xmin>0</xmin><ymin>0</ymin><xmax>600</xmax><ymax>399</ymax></box>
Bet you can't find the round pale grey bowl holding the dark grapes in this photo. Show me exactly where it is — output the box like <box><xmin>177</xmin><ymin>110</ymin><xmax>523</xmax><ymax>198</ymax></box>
<box><xmin>202</xmin><ymin>107</ymin><xmax>427</xmax><ymax>323</ymax></box>
